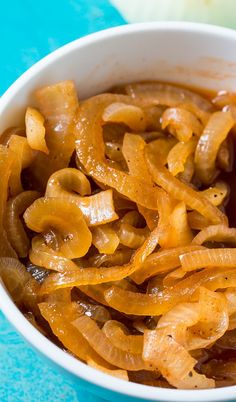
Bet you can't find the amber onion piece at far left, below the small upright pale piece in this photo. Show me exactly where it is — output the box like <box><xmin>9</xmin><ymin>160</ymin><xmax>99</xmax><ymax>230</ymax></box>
<box><xmin>8</xmin><ymin>135</ymin><xmax>35</xmax><ymax>197</ymax></box>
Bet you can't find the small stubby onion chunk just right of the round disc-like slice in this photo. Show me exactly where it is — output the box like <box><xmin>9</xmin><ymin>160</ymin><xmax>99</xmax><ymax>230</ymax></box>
<box><xmin>92</xmin><ymin>224</ymin><xmax>120</xmax><ymax>254</ymax></box>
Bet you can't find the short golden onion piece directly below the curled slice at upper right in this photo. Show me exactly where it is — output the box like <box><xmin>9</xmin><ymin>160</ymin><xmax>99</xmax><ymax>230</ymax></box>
<box><xmin>167</xmin><ymin>138</ymin><xmax>197</xmax><ymax>176</ymax></box>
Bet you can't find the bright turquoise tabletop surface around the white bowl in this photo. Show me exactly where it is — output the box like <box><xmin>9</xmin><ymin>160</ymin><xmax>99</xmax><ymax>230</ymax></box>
<box><xmin>0</xmin><ymin>0</ymin><xmax>125</xmax><ymax>402</ymax></box>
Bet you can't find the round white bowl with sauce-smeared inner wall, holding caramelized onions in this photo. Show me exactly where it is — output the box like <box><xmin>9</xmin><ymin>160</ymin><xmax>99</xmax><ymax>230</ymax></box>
<box><xmin>0</xmin><ymin>22</ymin><xmax>236</xmax><ymax>402</ymax></box>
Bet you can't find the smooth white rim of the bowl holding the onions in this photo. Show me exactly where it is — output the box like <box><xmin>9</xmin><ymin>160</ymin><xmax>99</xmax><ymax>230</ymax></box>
<box><xmin>0</xmin><ymin>21</ymin><xmax>236</xmax><ymax>402</ymax></box>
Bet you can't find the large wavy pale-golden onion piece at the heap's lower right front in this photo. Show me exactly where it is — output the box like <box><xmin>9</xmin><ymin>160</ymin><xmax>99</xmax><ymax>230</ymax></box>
<box><xmin>143</xmin><ymin>288</ymin><xmax>220</xmax><ymax>389</ymax></box>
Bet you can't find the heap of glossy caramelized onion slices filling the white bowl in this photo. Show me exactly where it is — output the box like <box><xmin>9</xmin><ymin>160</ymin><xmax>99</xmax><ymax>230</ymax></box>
<box><xmin>0</xmin><ymin>81</ymin><xmax>236</xmax><ymax>389</ymax></box>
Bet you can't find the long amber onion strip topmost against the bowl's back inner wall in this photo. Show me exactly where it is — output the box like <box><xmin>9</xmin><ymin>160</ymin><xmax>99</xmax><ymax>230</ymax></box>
<box><xmin>125</xmin><ymin>81</ymin><xmax>212</xmax><ymax>112</ymax></box>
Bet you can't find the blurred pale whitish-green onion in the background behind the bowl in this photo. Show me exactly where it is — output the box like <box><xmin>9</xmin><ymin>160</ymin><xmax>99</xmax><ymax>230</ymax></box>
<box><xmin>110</xmin><ymin>0</ymin><xmax>236</xmax><ymax>28</ymax></box>
